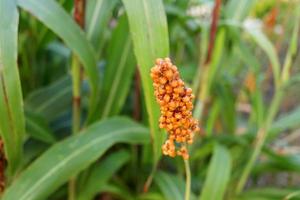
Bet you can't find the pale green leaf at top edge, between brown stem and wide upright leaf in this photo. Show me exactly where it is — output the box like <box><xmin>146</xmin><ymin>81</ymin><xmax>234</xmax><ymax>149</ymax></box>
<box><xmin>86</xmin><ymin>0</ymin><xmax>118</xmax><ymax>56</ymax></box>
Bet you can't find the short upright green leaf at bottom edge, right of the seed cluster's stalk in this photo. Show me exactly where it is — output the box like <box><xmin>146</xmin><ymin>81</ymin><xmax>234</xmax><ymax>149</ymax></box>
<box><xmin>200</xmin><ymin>144</ymin><xmax>231</xmax><ymax>200</ymax></box>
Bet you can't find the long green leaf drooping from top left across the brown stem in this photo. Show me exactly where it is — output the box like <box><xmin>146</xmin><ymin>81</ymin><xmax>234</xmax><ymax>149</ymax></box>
<box><xmin>18</xmin><ymin>0</ymin><xmax>99</xmax><ymax>115</ymax></box>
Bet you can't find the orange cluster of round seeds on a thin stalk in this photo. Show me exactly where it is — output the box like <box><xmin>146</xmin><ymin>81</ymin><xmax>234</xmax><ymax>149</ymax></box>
<box><xmin>151</xmin><ymin>58</ymin><xmax>199</xmax><ymax>159</ymax></box>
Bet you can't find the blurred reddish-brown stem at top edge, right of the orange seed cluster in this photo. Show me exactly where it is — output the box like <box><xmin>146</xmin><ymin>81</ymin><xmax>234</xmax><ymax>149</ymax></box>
<box><xmin>204</xmin><ymin>0</ymin><xmax>222</xmax><ymax>66</ymax></box>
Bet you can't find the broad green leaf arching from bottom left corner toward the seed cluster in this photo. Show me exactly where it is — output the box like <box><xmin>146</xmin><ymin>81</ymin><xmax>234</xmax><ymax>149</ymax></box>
<box><xmin>3</xmin><ymin>118</ymin><xmax>149</xmax><ymax>200</ymax></box>
